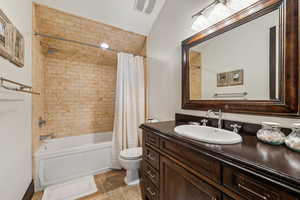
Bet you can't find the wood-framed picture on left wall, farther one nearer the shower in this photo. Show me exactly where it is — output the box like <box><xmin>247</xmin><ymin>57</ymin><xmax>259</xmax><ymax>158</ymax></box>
<box><xmin>11</xmin><ymin>27</ymin><xmax>25</xmax><ymax>67</ymax></box>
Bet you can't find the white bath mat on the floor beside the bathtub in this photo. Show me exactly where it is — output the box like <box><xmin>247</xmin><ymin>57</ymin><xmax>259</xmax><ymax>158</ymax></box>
<box><xmin>42</xmin><ymin>176</ymin><xmax>97</xmax><ymax>200</ymax></box>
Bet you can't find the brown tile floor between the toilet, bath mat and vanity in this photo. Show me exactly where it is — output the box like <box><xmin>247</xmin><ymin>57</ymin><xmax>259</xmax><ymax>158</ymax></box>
<box><xmin>32</xmin><ymin>171</ymin><xmax>142</xmax><ymax>200</ymax></box>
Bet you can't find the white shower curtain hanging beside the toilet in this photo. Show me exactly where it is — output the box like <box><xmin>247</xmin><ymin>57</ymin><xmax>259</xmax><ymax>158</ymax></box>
<box><xmin>112</xmin><ymin>53</ymin><xmax>145</xmax><ymax>169</ymax></box>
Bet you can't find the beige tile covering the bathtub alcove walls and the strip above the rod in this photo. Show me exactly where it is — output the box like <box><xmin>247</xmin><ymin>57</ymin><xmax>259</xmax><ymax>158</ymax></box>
<box><xmin>33</xmin><ymin>4</ymin><xmax>146</xmax><ymax>150</ymax></box>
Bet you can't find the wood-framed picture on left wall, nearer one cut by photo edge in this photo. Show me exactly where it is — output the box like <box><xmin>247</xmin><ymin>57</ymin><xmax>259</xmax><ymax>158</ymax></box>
<box><xmin>0</xmin><ymin>9</ymin><xmax>13</xmax><ymax>60</ymax></box>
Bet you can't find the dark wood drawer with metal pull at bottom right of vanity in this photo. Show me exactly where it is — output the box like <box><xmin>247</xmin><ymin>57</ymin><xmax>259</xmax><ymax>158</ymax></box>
<box><xmin>223</xmin><ymin>166</ymin><xmax>298</xmax><ymax>200</ymax></box>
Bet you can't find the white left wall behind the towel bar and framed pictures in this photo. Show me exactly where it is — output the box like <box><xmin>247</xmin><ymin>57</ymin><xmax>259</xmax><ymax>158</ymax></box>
<box><xmin>0</xmin><ymin>0</ymin><xmax>32</xmax><ymax>200</ymax></box>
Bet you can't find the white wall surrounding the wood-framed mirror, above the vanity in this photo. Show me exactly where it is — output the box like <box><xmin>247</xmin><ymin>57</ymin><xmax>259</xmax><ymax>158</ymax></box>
<box><xmin>147</xmin><ymin>0</ymin><xmax>298</xmax><ymax>127</ymax></box>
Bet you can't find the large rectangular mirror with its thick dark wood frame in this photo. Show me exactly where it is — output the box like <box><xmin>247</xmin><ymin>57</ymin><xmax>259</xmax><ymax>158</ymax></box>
<box><xmin>182</xmin><ymin>0</ymin><xmax>299</xmax><ymax>117</ymax></box>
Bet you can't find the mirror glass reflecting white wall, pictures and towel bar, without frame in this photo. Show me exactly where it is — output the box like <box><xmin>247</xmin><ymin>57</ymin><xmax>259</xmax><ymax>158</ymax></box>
<box><xmin>189</xmin><ymin>10</ymin><xmax>282</xmax><ymax>100</ymax></box>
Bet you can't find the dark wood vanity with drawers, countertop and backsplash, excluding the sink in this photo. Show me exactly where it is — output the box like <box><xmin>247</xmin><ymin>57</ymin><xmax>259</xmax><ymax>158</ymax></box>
<box><xmin>141</xmin><ymin>115</ymin><xmax>300</xmax><ymax>200</ymax></box>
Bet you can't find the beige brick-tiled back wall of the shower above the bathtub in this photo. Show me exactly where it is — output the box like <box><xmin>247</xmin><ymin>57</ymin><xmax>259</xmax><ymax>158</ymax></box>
<box><xmin>45</xmin><ymin>57</ymin><xmax>116</xmax><ymax>137</ymax></box>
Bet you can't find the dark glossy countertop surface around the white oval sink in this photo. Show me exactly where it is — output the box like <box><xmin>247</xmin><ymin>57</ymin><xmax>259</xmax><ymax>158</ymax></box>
<box><xmin>141</xmin><ymin>121</ymin><xmax>300</xmax><ymax>192</ymax></box>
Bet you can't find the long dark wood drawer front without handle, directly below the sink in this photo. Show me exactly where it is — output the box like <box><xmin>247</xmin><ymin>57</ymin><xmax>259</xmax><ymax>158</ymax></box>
<box><xmin>160</xmin><ymin>139</ymin><xmax>221</xmax><ymax>183</ymax></box>
